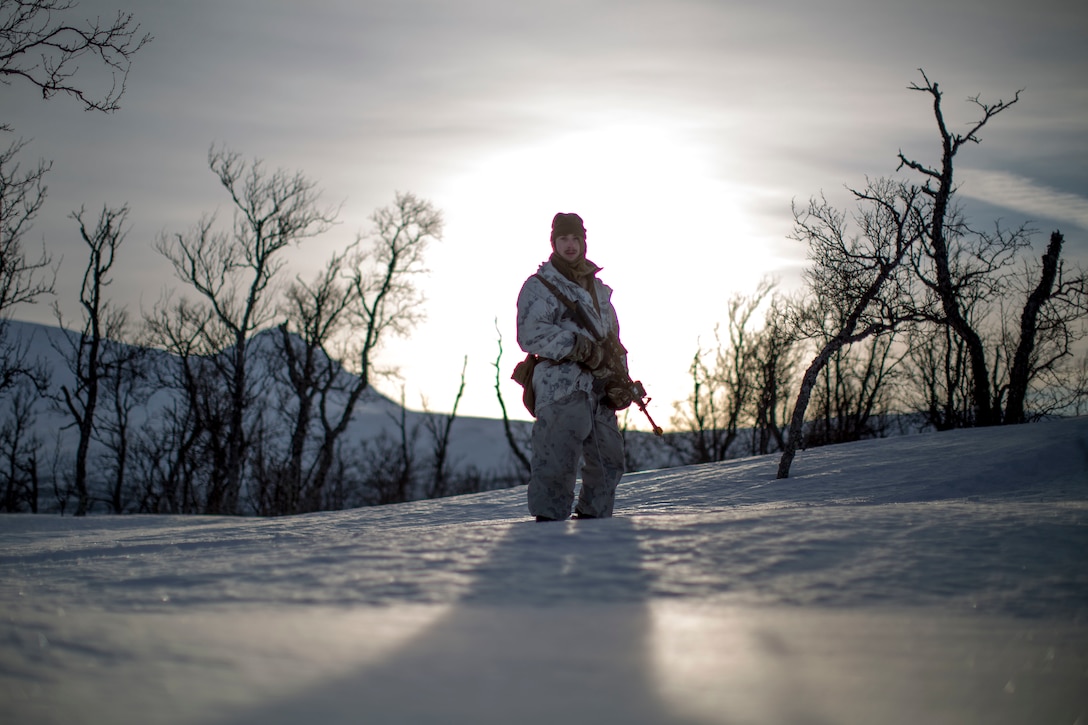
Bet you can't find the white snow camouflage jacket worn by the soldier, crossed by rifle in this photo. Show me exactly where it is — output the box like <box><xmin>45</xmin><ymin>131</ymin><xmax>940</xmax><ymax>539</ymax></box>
<box><xmin>518</xmin><ymin>261</ymin><xmax>619</xmax><ymax>410</ymax></box>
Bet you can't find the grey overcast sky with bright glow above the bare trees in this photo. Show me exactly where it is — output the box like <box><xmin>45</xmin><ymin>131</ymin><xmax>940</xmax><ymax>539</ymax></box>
<box><xmin>0</xmin><ymin>0</ymin><xmax>1088</xmax><ymax>422</ymax></box>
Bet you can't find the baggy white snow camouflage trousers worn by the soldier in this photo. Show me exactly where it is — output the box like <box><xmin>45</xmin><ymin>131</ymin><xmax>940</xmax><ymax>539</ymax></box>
<box><xmin>528</xmin><ymin>392</ymin><xmax>623</xmax><ymax>519</ymax></box>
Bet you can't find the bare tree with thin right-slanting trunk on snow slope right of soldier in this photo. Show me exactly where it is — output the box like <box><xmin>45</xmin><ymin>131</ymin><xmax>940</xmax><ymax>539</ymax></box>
<box><xmin>778</xmin><ymin>180</ymin><xmax>924</xmax><ymax>478</ymax></box>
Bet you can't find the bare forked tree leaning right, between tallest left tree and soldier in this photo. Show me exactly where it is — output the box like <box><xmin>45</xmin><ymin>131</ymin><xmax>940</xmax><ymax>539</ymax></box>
<box><xmin>254</xmin><ymin>189</ymin><xmax>442</xmax><ymax>513</ymax></box>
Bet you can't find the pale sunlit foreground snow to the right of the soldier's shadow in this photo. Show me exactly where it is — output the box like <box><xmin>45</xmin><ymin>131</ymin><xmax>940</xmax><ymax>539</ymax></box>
<box><xmin>650</xmin><ymin>600</ymin><xmax>1085</xmax><ymax>724</ymax></box>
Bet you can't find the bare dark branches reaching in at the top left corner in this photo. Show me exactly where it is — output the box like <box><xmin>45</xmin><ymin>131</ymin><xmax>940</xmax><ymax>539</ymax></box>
<box><xmin>0</xmin><ymin>0</ymin><xmax>152</xmax><ymax>120</ymax></box>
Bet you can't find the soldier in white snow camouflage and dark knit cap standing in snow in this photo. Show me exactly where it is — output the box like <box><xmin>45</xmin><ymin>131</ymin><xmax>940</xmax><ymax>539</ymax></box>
<box><xmin>518</xmin><ymin>212</ymin><xmax>632</xmax><ymax>521</ymax></box>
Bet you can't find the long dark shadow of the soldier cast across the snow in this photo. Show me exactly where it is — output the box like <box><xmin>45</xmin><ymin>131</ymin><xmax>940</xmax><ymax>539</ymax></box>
<box><xmin>212</xmin><ymin>518</ymin><xmax>718</xmax><ymax>725</ymax></box>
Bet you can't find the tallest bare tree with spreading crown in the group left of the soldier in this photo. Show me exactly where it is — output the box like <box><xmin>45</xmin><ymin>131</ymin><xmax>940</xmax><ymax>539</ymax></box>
<box><xmin>150</xmin><ymin>147</ymin><xmax>336</xmax><ymax>513</ymax></box>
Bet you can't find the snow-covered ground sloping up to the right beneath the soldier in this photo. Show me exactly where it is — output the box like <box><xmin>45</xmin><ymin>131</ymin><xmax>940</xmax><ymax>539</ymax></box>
<box><xmin>0</xmin><ymin>419</ymin><xmax>1088</xmax><ymax>725</ymax></box>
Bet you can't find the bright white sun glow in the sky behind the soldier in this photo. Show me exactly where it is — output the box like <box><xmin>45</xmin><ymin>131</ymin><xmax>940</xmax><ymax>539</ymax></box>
<box><xmin>404</xmin><ymin>117</ymin><xmax>781</xmax><ymax>422</ymax></box>
